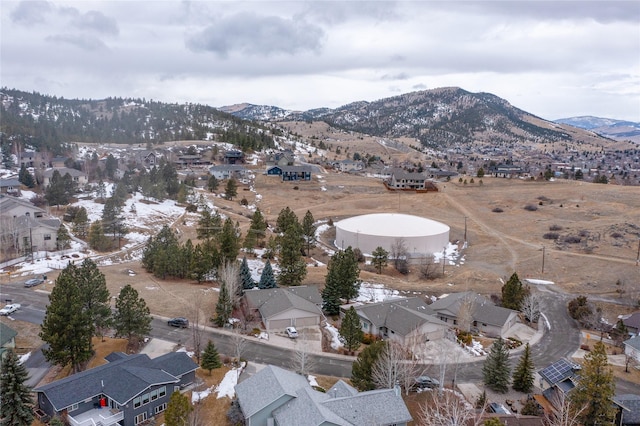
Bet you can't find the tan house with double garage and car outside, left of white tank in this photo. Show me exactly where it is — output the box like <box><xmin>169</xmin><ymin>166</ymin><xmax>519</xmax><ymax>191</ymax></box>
<box><xmin>244</xmin><ymin>286</ymin><xmax>322</xmax><ymax>330</ymax></box>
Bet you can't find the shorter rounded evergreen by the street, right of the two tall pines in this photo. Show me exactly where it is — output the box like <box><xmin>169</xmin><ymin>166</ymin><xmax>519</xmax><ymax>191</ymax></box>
<box><xmin>113</xmin><ymin>284</ymin><xmax>152</xmax><ymax>341</ymax></box>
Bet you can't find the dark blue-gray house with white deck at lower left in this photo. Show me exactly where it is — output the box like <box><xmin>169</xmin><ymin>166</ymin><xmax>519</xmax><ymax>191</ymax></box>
<box><xmin>34</xmin><ymin>352</ymin><xmax>198</xmax><ymax>426</ymax></box>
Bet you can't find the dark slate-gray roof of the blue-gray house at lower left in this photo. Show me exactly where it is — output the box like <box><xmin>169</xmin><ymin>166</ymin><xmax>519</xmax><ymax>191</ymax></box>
<box><xmin>34</xmin><ymin>352</ymin><xmax>198</xmax><ymax>411</ymax></box>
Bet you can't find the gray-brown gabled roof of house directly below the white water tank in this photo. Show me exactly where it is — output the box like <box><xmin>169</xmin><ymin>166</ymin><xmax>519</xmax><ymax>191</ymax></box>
<box><xmin>354</xmin><ymin>297</ymin><xmax>448</xmax><ymax>336</ymax></box>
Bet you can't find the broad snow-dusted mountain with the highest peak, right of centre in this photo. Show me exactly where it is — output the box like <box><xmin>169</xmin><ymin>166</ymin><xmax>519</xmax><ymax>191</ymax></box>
<box><xmin>226</xmin><ymin>87</ymin><xmax>616</xmax><ymax>147</ymax></box>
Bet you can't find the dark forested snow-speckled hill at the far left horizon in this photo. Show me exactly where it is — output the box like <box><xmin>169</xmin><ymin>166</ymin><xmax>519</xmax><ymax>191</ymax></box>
<box><xmin>0</xmin><ymin>88</ymin><xmax>274</xmax><ymax>153</ymax></box>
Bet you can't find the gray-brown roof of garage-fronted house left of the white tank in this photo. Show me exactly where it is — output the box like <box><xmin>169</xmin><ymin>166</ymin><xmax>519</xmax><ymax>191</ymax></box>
<box><xmin>244</xmin><ymin>287</ymin><xmax>322</xmax><ymax>318</ymax></box>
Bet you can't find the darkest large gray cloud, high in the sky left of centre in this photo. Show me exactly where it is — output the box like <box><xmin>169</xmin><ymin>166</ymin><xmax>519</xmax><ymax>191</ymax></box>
<box><xmin>186</xmin><ymin>13</ymin><xmax>324</xmax><ymax>57</ymax></box>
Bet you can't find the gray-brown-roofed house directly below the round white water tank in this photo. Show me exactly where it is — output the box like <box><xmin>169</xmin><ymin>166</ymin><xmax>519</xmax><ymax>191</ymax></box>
<box><xmin>341</xmin><ymin>297</ymin><xmax>449</xmax><ymax>346</ymax></box>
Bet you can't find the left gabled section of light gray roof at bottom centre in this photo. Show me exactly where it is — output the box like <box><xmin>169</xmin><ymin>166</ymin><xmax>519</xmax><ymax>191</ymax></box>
<box><xmin>235</xmin><ymin>365</ymin><xmax>309</xmax><ymax>418</ymax></box>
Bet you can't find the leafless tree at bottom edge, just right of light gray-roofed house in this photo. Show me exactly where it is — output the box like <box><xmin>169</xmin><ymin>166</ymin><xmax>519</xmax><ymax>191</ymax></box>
<box><xmin>420</xmin><ymin>390</ymin><xmax>482</xmax><ymax>426</ymax></box>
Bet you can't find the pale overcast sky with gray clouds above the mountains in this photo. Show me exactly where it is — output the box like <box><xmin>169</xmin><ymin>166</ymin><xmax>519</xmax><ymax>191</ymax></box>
<box><xmin>0</xmin><ymin>0</ymin><xmax>640</xmax><ymax>122</ymax></box>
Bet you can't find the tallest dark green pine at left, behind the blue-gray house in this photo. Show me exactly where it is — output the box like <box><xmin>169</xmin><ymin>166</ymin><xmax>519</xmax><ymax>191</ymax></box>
<box><xmin>39</xmin><ymin>263</ymin><xmax>93</xmax><ymax>372</ymax></box>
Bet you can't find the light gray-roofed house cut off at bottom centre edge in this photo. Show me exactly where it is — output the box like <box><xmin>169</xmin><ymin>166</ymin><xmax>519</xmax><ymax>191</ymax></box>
<box><xmin>235</xmin><ymin>365</ymin><xmax>412</xmax><ymax>426</ymax></box>
